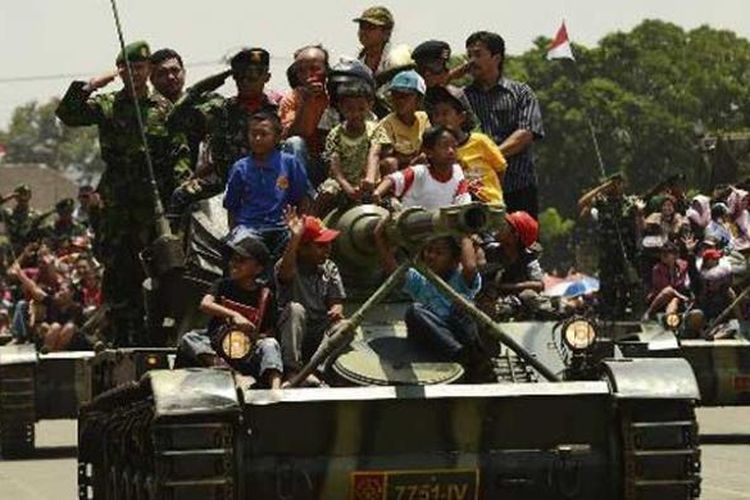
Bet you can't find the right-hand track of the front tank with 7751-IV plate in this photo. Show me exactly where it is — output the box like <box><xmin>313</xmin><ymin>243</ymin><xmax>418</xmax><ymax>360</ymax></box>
<box><xmin>620</xmin><ymin>399</ymin><xmax>701</xmax><ymax>500</ymax></box>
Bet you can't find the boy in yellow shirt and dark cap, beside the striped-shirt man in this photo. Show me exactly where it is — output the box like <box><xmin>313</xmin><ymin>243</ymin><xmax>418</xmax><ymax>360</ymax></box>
<box><xmin>426</xmin><ymin>85</ymin><xmax>507</xmax><ymax>204</ymax></box>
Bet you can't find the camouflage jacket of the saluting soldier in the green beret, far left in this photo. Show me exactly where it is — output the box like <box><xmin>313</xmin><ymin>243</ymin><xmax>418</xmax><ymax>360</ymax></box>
<box><xmin>57</xmin><ymin>81</ymin><xmax>191</xmax><ymax>206</ymax></box>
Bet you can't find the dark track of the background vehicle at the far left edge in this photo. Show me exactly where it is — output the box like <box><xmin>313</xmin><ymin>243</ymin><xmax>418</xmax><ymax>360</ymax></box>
<box><xmin>0</xmin><ymin>364</ymin><xmax>36</xmax><ymax>458</ymax></box>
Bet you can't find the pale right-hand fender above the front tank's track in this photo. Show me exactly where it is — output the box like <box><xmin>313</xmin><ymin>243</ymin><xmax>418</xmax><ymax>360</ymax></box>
<box><xmin>604</xmin><ymin>358</ymin><xmax>700</xmax><ymax>401</ymax></box>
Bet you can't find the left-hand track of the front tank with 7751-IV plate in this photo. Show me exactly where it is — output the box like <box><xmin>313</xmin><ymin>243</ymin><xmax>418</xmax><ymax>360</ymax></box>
<box><xmin>78</xmin><ymin>379</ymin><xmax>240</xmax><ymax>500</ymax></box>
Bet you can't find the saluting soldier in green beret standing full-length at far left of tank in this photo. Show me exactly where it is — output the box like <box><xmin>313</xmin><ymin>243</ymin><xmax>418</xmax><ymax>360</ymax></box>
<box><xmin>57</xmin><ymin>42</ymin><xmax>190</xmax><ymax>345</ymax></box>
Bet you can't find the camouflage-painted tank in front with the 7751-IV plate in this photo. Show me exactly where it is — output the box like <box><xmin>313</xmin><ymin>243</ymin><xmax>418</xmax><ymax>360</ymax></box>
<box><xmin>73</xmin><ymin>201</ymin><xmax>700</xmax><ymax>500</ymax></box>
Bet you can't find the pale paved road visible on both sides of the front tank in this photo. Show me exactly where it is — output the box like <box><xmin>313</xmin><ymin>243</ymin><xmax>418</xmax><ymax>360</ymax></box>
<box><xmin>0</xmin><ymin>408</ymin><xmax>750</xmax><ymax>500</ymax></box>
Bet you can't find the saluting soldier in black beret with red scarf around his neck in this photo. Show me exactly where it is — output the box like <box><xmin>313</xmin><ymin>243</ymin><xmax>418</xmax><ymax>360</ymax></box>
<box><xmin>167</xmin><ymin>48</ymin><xmax>280</xmax><ymax>212</ymax></box>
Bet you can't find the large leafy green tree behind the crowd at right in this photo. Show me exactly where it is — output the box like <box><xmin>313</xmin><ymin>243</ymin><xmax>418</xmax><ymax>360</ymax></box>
<box><xmin>506</xmin><ymin>20</ymin><xmax>750</xmax><ymax>217</ymax></box>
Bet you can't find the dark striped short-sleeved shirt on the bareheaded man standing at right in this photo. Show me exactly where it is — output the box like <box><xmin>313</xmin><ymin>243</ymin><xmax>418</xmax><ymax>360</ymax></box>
<box><xmin>464</xmin><ymin>78</ymin><xmax>544</xmax><ymax>193</ymax></box>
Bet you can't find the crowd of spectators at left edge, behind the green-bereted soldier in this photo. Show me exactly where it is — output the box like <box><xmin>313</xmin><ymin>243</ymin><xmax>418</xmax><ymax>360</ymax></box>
<box><xmin>0</xmin><ymin>185</ymin><xmax>102</xmax><ymax>352</ymax></box>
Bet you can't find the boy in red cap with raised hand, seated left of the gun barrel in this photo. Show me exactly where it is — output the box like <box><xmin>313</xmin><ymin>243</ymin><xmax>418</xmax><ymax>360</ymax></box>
<box><xmin>275</xmin><ymin>208</ymin><xmax>346</xmax><ymax>385</ymax></box>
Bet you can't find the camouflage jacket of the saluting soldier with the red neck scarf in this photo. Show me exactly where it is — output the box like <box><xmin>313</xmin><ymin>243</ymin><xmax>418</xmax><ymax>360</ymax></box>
<box><xmin>167</xmin><ymin>91</ymin><xmax>278</xmax><ymax>182</ymax></box>
